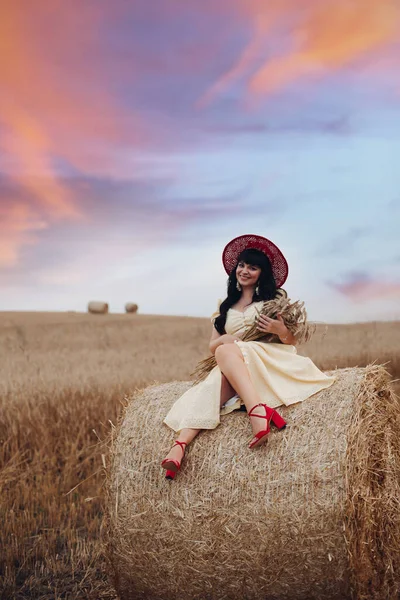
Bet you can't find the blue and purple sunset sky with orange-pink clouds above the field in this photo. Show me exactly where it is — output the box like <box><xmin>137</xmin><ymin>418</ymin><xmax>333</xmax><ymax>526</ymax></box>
<box><xmin>0</xmin><ymin>0</ymin><xmax>400</xmax><ymax>323</ymax></box>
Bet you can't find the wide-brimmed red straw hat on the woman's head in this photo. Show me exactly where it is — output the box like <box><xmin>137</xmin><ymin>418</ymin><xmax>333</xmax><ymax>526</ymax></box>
<box><xmin>222</xmin><ymin>233</ymin><xmax>289</xmax><ymax>288</ymax></box>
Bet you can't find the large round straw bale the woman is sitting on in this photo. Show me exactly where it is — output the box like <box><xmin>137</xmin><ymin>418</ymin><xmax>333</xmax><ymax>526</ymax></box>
<box><xmin>107</xmin><ymin>366</ymin><xmax>400</xmax><ymax>600</ymax></box>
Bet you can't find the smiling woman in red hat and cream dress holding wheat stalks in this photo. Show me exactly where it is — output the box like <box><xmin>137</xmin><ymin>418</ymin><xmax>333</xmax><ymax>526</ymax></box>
<box><xmin>161</xmin><ymin>235</ymin><xmax>335</xmax><ymax>479</ymax></box>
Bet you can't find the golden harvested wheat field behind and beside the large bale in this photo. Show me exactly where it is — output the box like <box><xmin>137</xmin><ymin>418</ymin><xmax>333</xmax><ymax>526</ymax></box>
<box><xmin>0</xmin><ymin>312</ymin><xmax>400</xmax><ymax>600</ymax></box>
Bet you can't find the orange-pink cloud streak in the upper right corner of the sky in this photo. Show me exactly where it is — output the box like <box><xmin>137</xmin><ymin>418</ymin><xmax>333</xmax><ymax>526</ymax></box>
<box><xmin>199</xmin><ymin>0</ymin><xmax>400</xmax><ymax>106</ymax></box>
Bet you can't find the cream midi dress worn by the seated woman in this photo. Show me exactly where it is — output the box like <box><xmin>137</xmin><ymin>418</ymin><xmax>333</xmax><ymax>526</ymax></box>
<box><xmin>164</xmin><ymin>301</ymin><xmax>335</xmax><ymax>432</ymax></box>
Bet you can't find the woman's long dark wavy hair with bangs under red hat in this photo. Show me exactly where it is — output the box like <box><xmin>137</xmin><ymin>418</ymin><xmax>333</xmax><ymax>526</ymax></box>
<box><xmin>214</xmin><ymin>248</ymin><xmax>277</xmax><ymax>335</ymax></box>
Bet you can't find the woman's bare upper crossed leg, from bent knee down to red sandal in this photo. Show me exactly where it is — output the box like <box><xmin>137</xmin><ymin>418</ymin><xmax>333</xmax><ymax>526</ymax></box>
<box><xmin>215</xmin><ymin>344</ymin><xmax>266</xmax><ymax>442</ymax></box>
